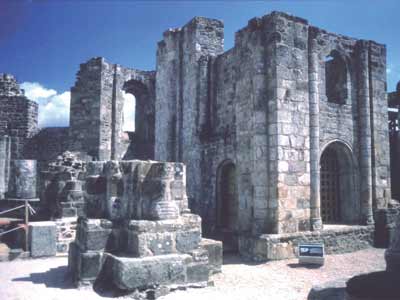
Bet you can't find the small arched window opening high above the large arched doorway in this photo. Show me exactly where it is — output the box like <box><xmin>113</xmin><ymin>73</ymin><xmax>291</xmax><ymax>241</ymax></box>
<box><xmin>325</xmin><ymin>51</ymin><xmax>348</xmax><ymax>104</ymax></box>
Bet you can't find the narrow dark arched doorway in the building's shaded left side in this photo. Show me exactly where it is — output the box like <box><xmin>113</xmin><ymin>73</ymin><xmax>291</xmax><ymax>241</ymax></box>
<box><xmin>217</xmin><ymin>160</ymin><xmax>239</xmax><ymax>252</ymax></box>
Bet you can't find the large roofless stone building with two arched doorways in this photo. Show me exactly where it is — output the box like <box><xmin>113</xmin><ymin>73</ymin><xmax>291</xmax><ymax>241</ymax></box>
<box><xmin>155</xmin><ymin>12</ymin><xmax>390</xmax><ymax>238</ymax></box>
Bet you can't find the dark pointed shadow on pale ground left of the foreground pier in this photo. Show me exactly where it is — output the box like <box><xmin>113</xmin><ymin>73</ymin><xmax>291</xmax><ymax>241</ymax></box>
<box><xmin>12</xmin><ymin>266</ymin><xmax>74</xmax><ymax>289</ymax></box>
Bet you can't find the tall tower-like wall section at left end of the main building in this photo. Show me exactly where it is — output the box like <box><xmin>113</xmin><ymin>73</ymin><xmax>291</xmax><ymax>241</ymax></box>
<box><xmin>155</xmin><ymin>17</ymin><xmax>227</xmax><ymax>230</ymax></box>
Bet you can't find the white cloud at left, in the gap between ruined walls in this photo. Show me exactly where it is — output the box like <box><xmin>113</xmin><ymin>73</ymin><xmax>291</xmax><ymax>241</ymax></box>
<box><xmin>21</xmin><ymin>82</ymin><xmax>71</xmax><ymax>128</ymax></box>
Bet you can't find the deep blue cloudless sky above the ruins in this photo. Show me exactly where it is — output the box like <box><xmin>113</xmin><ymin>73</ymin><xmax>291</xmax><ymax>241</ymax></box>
<box><xmin>0</xmin><ymin>0</ymin><xmax>400</xmax><ymax>92</ymax></box>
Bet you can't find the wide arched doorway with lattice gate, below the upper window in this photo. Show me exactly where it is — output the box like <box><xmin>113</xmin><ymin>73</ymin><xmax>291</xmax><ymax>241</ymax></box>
<box><xmin>320</xmin><ymin>141</ymin><xmax>360</xmax><ymax>224</ymax></box>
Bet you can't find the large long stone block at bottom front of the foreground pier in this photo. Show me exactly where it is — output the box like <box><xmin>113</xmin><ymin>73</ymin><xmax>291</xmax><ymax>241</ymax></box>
<box><xmin>106</xmin><ymin>254</ymin><xmax>190</xmax><ymax>290</ymax></box>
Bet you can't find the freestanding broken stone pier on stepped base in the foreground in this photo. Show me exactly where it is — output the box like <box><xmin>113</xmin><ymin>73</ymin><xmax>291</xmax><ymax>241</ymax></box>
<box><xmin>68</xmin><ymin>160</ymin><xmax>222</xmax><ymax>292</ymax></box>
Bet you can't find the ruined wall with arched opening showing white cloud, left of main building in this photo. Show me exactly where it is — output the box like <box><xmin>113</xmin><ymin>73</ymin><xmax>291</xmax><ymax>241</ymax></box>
<box><xmin>69</xmin><ymin>58</ymin><xmax>154</xmax><ymax>160</ymax></box>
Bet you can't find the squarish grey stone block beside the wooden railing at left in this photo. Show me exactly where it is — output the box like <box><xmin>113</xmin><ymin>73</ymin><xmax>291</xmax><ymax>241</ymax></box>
<box><xmin>29</xmin><ymin>221</ymin><xmax>57</xmax><ymax>257</ymax></box>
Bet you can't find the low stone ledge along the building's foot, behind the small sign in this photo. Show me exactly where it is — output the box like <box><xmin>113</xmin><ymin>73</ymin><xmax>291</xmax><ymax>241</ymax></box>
<box><xmin>239</xmin><ymin>225</ymin><xmax>375</xmax><ymax>261</ymax></box>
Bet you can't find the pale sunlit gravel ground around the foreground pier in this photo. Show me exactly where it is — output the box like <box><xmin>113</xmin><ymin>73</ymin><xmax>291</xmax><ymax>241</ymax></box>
<box><xmin>0</xmin><ymin>249</ymin><xmax>385</xmax><ymax>300</ymax></box>
